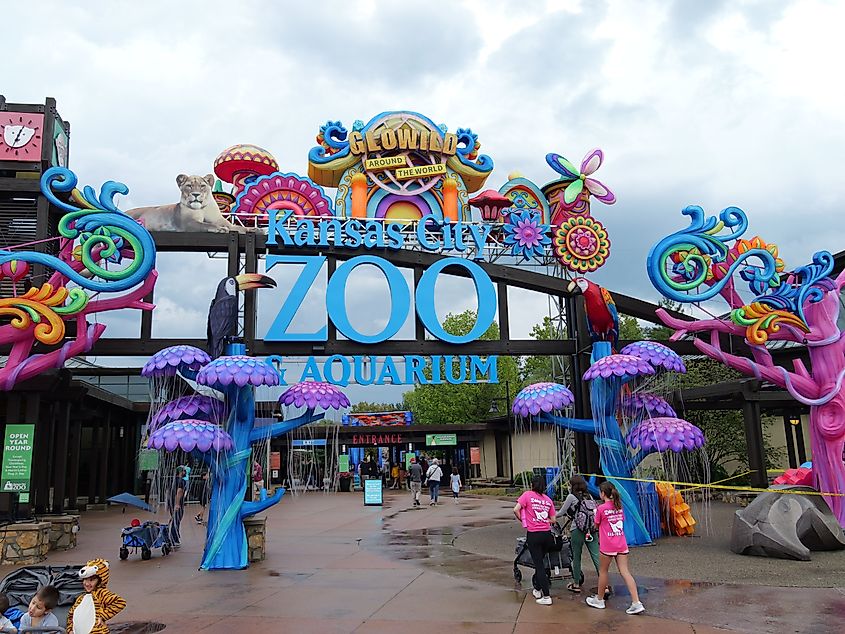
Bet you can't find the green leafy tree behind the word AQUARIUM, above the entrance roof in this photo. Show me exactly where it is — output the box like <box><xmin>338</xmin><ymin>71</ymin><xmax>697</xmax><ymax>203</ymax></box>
<box><xmin>403</xmin><ymin>310</ymin><xmax>520</xmax><ymax>425</ymax></box>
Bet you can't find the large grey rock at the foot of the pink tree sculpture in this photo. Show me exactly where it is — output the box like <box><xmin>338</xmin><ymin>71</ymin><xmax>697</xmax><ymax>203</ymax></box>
<box><xmin>731</xmin><ymin>486</ymin><xmax>845</xmax><ymax>561</ymax></box>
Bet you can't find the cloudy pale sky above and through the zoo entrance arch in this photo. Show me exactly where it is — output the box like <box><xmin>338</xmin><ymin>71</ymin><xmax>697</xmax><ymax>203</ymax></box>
<box><xmin>0</xmin><ymin>0</ymin><xmax>845</xmax><ymax>400</ymax></box>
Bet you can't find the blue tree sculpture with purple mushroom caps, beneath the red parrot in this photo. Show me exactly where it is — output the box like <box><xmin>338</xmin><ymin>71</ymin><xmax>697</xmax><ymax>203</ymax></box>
<box><xmin>514</xmin><ymin>341</ymin><xmax>688</xmax><ymax>545</ymax></box>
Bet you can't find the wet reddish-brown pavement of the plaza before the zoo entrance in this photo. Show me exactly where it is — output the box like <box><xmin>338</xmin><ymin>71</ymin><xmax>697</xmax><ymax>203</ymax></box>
<box><xmin>9</xmin><ymin>492</ymin><xmax>845</xmax><ymax>634</ymax></box>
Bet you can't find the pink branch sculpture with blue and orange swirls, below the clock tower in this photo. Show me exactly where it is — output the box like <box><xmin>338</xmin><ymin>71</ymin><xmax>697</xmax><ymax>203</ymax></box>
<box><xmin>0</xmin><ymin>167</ymin><xmax>156</xmax><ymax>390</ymax></box>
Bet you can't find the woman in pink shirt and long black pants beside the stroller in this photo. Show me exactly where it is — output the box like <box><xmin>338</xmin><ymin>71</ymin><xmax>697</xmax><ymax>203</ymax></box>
<box><xmin>513</xmin><ymin>476</ymin><xmax>555</xmax><ymax>605</ymax></box>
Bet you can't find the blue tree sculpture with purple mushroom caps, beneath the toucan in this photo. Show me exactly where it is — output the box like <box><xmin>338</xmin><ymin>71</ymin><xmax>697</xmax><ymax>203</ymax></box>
<box><xmin>142</xmin><ymin>344</ymin><xmax>349</xmax><ymax>570</ymax></box>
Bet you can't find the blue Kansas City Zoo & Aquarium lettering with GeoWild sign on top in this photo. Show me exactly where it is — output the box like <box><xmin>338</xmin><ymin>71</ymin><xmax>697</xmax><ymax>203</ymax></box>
<box><xmin>264</xmin><ymin>112</ymin><xmax>498</xmax><ymax>385</ymax></box>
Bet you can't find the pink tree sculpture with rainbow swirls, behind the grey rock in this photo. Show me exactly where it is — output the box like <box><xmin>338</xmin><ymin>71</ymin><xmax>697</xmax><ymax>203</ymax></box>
<box><xmin>646</xmin><ymin>206</ymin><xmax>845</xmax><ymax>526</ymax></box>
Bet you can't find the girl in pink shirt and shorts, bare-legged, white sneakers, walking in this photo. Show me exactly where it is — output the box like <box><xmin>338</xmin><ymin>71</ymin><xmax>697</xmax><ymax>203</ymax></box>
<box><xmin>587</xmin><ymin>482</ymin><xmax>645</xmax><ymax>614</ymax></box>
